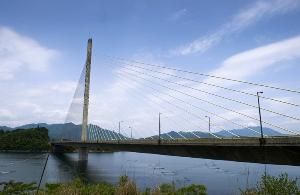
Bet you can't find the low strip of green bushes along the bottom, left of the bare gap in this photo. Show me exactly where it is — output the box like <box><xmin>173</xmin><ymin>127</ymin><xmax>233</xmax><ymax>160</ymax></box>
<box><xmin>0</xmin><ymin>176</ymin><xmax>206</xmax><ymax>195</ymax></box>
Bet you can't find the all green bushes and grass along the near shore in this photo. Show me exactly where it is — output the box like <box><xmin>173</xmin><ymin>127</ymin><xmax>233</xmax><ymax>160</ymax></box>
<box><xmin>0</xmin><ymin>174</ymin><xmax>300</xmax><ymax>195</ymax></box>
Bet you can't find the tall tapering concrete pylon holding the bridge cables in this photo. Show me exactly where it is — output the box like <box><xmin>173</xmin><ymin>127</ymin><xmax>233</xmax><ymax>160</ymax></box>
<box><xmin>81</xmin><ymin>39</ymin><xmax>92</xmax><ymax>142</ymax></box>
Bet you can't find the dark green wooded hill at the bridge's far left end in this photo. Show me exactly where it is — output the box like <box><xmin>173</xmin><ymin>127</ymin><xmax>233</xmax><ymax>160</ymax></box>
<box><xmin>0</xmin><ymin>127</ymin><xmax>49</xmax><ymax>151</ymax></box>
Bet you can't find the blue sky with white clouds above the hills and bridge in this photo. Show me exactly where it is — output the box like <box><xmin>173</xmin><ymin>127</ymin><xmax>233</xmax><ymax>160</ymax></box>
<box><xmin>0</xmin><ymin>0</ymin><xmax>300</xmax><ymax>137</ymax></box>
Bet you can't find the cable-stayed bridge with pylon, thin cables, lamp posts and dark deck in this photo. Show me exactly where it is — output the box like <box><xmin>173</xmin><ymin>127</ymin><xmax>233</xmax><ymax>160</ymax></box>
<box><xmin>51</xmin><ymin>39</ymin><xmax>300</xmax><ymax>165</ymax></box>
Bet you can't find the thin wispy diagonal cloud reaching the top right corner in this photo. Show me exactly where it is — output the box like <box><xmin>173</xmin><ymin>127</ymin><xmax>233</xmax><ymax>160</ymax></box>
<box><xmin>171</xmin><ymin>0</ymin><xmax>300</xmax><ymax>55</ymax></box>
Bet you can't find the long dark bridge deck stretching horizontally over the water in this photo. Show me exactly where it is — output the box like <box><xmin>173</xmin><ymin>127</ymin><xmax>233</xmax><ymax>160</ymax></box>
<box><xmin>51</xmin><ymin>137</ymin><xmax>300</xmax><ymax>166</ymax></box>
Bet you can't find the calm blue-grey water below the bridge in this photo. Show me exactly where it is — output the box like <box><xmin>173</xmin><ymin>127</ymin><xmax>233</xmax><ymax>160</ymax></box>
<box><xmin>0</xmin><ymin>152</ymin><xmax>300</xmax><ymax>194</ymax></box>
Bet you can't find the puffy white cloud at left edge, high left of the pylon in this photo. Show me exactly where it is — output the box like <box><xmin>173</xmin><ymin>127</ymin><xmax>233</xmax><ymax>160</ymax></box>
<box><xmin>0</xmin><ymin>26</ymin><xmax>58</xmax><ymax>80</ymax></box>
